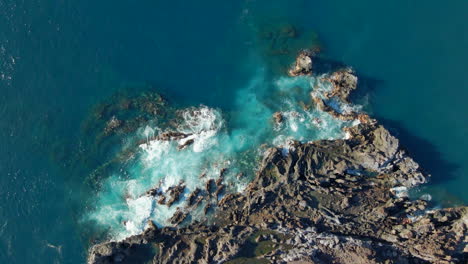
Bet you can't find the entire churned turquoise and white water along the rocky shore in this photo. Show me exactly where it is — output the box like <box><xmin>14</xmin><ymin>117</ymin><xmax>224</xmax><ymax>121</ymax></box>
<box><xmin>87</xmin><ymin>70</ymin><xmax>351</xmax><ymax>240</ymax></box>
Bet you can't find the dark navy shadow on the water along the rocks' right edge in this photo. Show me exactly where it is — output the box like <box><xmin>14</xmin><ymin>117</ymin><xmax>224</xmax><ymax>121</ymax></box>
<box><xmin>377</xmin><ymin>117</ymin><xmax>460</xmax><ymax>183</ymax></box>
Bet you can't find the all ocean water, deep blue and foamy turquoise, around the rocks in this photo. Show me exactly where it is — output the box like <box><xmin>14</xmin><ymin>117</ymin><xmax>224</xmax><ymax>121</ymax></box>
<box><xmin>0</xmin><ymin>0</ymin><xmax>468</xmax><ymax>263</ymax></box>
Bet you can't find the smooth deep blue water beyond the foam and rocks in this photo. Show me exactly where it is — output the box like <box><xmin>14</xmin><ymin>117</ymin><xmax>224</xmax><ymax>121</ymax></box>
<box><xmin>0</xmin><ymin>0</ymin><xmax>468</xmax><ymax>263</ymax></box>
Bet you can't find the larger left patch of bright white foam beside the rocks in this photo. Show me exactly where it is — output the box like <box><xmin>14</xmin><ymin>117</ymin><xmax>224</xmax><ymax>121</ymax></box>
<box><xmin>91</xmin><ymin>106</ymin><xmax>235</xmax><ymax>239</ymax></box>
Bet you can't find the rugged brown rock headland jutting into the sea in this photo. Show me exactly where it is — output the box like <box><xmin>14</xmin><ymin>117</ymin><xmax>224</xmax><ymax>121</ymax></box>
<box><xmin>88</xmin><ymin>53</ymin><xmax>468</xmax><ymax>263</ymax></box>
